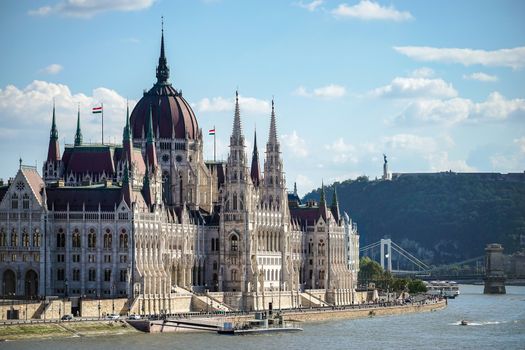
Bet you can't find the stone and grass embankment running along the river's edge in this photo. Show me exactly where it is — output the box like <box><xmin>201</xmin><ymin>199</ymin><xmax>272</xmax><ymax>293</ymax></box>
<box><xmin>0</xmin><ymin>296</ymin><xmax>447</xmax><ymax>339</ymax></box>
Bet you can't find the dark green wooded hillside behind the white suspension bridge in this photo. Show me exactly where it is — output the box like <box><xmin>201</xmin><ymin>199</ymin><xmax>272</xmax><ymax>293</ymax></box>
<box><xmin>304</xmin><ymin>173</ymin><xmax>525</xmax><ymax>264</ymax></box>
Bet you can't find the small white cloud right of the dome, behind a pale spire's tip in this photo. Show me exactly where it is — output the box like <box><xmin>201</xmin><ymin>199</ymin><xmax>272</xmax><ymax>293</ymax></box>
<box><xmin>192</xmin><ymin>95</ymin><xmax>271</xmax><ymax>114</ymax></box>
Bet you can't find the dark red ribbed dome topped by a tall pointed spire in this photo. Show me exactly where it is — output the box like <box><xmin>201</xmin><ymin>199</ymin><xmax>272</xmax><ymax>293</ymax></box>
<box><xmin>131</xmin><ymin>29</ymin><xmax>199</xmax><ymax>140</ymax></box>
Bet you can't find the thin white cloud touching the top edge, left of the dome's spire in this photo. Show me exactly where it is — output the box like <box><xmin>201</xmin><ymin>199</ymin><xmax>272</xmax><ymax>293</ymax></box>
<box><xmin>29</xmin><ymin>0</ymin><xmax>154</xmax><ymax>18</ymax></box>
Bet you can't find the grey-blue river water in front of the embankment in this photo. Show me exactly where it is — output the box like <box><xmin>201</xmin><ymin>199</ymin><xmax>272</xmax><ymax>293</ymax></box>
<box><xmin>0</xmin><ymin>285</ymin><xmax>525</xmax><ymax>350</ymax></box>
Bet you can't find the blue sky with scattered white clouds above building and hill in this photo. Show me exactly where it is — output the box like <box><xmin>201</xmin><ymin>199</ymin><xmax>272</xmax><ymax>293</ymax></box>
<box><xmin>0</xmin><ymin>0</ymin><xmax>525</xmax><ymax>193</ymax></box>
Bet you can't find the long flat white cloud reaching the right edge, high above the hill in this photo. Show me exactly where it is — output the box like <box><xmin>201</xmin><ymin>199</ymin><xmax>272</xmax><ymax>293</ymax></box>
<box><xmin>394</xmin><ymin>46</ymin><xmax>525</xmax><ymax>69</ymax></box>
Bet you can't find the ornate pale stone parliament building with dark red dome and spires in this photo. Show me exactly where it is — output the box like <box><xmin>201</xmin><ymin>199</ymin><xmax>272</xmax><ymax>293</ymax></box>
<box><xmin>0</xmin><ymin>33</ymin><xmax>359</xmax><ymax>314</ymax></box>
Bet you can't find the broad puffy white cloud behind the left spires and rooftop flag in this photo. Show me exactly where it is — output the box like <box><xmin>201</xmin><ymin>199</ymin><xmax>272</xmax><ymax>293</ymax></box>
<box><xmin>0</xmin><ymin>80</ymin><xmax>135</xmax><ymax>144</ymax></box>
